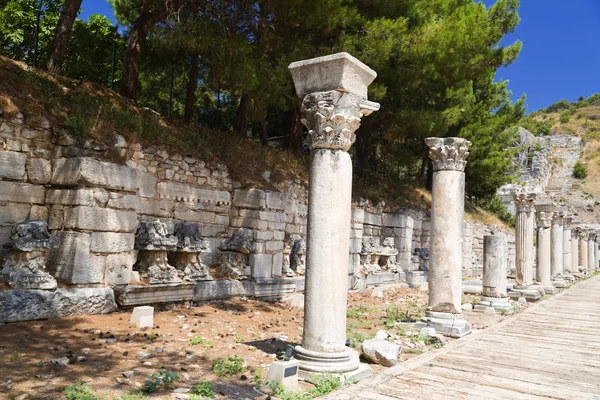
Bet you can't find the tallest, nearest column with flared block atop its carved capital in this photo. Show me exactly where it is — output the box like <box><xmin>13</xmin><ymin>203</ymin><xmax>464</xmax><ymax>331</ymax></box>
<box><xmin>289</xmin><ymin>53</ymin><xmax>379</xmax><ymax>374</ymax></box>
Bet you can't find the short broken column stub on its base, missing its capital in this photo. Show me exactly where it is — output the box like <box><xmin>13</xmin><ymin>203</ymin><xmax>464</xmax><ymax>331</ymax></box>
<box><xmin>474</xmin><ymin>235</ymin><xmax>514</xmax><ymax>314</ymax></box>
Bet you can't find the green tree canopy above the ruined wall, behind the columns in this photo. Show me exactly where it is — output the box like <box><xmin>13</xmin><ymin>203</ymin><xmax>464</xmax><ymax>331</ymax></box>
<box><xmin>0</xmin><ymin>0</ymin><xmax>524</xmax><ymax>199</ymax></box>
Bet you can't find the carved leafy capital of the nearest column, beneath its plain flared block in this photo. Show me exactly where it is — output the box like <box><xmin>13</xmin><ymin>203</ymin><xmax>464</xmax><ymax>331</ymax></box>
<box><xmin>302</xmin><ymin>90</ymin><xmax>379</xmax><ymax>151</ymax></box>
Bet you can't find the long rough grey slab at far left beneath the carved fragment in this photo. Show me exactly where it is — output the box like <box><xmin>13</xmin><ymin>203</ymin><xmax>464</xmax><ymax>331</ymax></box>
<box><xmin>0</xmin><ymin>287</ymin><xmax>117</xmax><ymax>323</ymax></box>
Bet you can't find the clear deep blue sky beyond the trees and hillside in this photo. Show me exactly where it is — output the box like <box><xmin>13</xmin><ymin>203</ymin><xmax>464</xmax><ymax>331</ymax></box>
<box><xmin>80</xmin><ymin>0</ymin><xmax>600</xmax><ymax>112</ymax></box>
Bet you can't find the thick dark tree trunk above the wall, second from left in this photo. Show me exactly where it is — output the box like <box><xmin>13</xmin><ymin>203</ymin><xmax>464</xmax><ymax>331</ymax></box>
<box><xmin>121</xmin><ymin>0</ymin><xmax>150</xmax><ymax>100</ymax></box>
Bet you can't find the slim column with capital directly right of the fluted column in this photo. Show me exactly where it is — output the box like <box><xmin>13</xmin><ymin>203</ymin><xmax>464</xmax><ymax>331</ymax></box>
<box><xmin>535</xmin><ymin>204</ymin><xmax>556</xmax><ymax>293</ymax></box>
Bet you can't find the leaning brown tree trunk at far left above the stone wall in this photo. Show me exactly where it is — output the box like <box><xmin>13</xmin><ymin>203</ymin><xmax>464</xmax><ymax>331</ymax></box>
<box><xmin>48</xmin><ymin>0</ymin><xmax>83</xmax><ymax>75</ymax></box>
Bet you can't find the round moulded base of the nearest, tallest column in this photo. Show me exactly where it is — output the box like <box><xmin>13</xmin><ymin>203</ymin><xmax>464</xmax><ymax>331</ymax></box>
<box><xmin>294</xmin><ymin>346</ymin><xmax>360</xmax><ymax>376</ymax></box>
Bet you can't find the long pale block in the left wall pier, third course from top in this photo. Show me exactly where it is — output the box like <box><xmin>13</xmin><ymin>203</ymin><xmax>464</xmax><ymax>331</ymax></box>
<box><xmin>64</xmin><ymin>206</ymin><xmax>138</xmax><ymax>232</ymax></box>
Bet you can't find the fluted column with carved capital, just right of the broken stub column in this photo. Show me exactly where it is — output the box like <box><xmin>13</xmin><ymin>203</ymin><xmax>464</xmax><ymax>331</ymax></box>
<box><xmin>509</xmin><ymin>193</ymin><xmax>541</xmax><ymax>301</ymax></box>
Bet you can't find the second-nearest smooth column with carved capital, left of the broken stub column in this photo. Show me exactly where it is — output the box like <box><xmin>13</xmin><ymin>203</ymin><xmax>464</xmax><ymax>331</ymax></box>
<box><xmin>425</xmin><ymin>138</ymin><xmax>471</xmax><ymax>337</ymax></box>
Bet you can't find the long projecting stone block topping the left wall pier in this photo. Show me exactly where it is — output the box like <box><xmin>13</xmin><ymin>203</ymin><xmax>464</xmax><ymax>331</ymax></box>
<box><xmin>52</xmin><ymin>157</ymin><xmax>140</xmax><ymax>192</ymax></box>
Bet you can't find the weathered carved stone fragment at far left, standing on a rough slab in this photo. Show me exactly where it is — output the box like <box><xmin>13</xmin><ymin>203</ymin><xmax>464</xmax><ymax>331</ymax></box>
<box><xmin>0</xmin><ymin>220</ymin><xmax>59</xmax><ymax>290</ymax></box>
